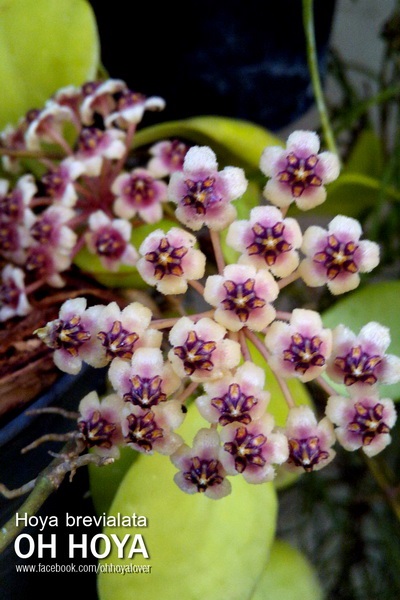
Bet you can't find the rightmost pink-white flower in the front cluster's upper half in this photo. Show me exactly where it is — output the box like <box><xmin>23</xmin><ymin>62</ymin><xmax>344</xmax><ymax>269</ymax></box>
<box><xmin>299</xmin><ymin>215</ymin><xmax>379</xmax><ymax>294</ymax></box>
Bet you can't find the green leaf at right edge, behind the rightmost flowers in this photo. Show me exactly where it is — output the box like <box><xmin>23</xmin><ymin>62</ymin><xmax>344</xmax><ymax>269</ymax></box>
<box><xmin>322</xmin><ymin>281</ymin><xmax>400</xmax><ymax>400</ymax></box>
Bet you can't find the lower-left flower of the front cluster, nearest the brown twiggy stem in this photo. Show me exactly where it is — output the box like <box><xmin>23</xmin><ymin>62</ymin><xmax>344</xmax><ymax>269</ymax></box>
<box><xmin>78</xmin><ymin>392</ymin><xmax>124</xmax><ymax>458</ymax></box>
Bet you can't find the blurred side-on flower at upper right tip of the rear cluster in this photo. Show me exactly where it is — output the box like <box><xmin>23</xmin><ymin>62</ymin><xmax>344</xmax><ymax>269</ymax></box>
<box><xmin>104</xmin><ymin>89</ymin><xmax>165</xmax><ymax>129</ymax></box>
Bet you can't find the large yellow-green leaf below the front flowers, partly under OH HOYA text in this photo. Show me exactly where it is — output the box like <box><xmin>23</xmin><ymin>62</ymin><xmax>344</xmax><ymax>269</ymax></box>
<box><xmin>98</xmin><ymin>400</ymin><xmax>277</xmax><ymax>600</ymax></box>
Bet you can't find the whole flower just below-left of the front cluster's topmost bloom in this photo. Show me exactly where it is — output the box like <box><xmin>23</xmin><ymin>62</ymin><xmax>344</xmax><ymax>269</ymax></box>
<box><xmin>226</xmin><ymin>206</ymin><xmax>302</xmax><ymax>277</ymax></box>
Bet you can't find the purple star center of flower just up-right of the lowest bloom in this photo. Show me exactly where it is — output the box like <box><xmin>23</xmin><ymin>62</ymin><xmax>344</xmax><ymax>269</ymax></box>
<box><xmin>224</xmin><ymin>427</ymin><xmax>267</xmax><ymax>473</ymax></box>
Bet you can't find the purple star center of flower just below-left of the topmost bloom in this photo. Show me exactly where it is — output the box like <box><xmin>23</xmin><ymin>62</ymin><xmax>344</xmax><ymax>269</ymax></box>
<box><xmin>246</xmin><ymin>221</ymin><xmax>292</xmax><ymax>266</ymax></box>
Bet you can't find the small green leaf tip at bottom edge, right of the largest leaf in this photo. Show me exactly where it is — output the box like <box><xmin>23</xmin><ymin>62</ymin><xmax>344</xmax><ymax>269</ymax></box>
<box><xmin>250</xmin><ymin>539</ymin><xmax>324</xmax><ymax>600</ymax></box>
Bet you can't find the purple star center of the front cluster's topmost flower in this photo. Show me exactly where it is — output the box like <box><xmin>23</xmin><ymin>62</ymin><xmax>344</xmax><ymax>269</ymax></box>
<box><xmin>278</xmin><ymin>152</ymin><xmax>322</xmax><ymax>198</ymax></box>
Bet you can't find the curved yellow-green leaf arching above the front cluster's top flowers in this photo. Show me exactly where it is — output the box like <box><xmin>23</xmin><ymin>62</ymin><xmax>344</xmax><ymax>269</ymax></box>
<box><xmin>133</xmin><ymin>116</ymin><xmax>284</xmax><ymax>181</ymax></box>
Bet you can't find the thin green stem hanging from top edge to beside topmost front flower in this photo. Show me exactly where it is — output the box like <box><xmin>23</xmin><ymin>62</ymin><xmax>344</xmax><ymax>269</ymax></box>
<box><xmin>303</xmin><ymin>0</ymin><xmax>338</xmax><ymax>155</ymax></box>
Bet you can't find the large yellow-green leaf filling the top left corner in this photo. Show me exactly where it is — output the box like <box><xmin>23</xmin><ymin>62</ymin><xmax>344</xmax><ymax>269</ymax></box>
<box><xmin>0</xmin><ymin>0</ymin><xmax>100</xmax><ymax>128</ymax></box>
